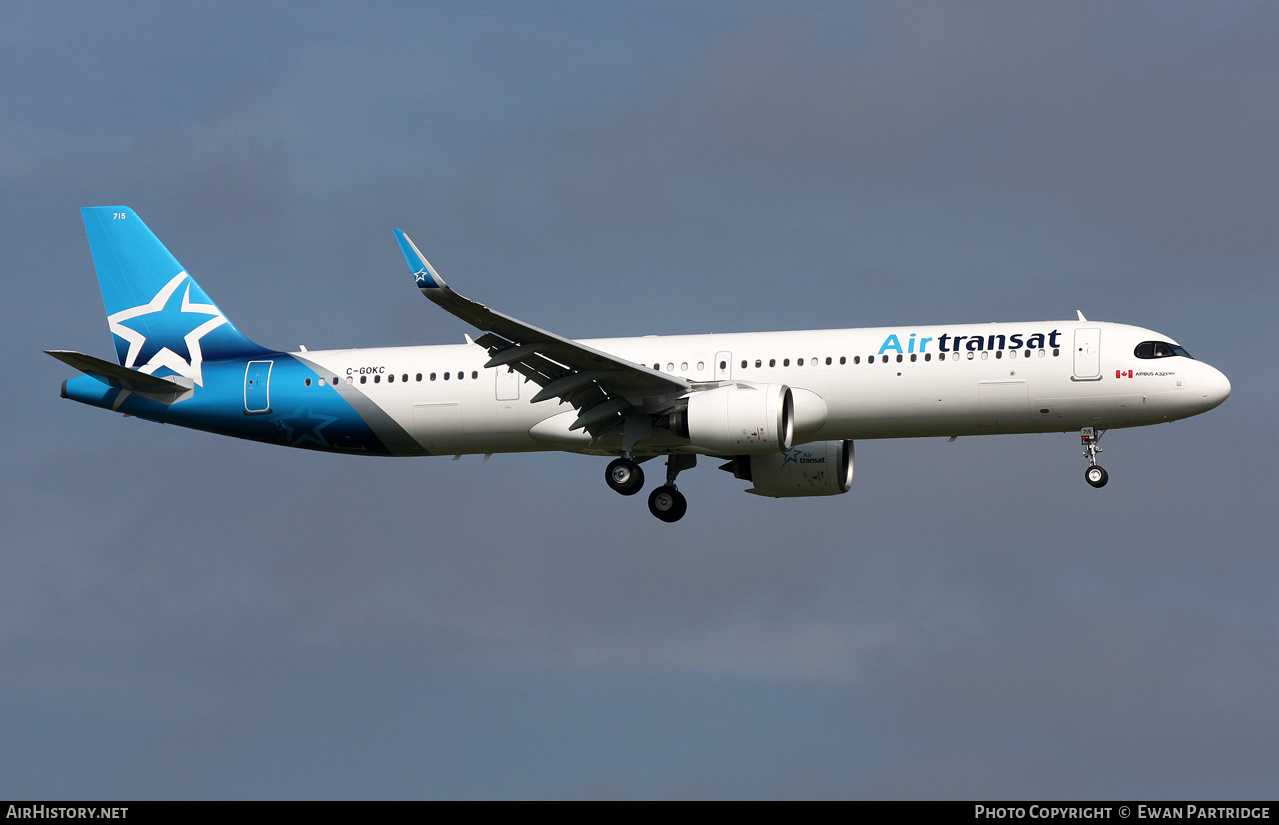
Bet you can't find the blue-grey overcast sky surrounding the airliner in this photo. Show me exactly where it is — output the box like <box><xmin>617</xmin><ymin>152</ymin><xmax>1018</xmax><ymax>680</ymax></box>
<box><xmin>0</xmin><ymin>1</ymin><xmax>1279</xmax><ymax>799</ymax></box>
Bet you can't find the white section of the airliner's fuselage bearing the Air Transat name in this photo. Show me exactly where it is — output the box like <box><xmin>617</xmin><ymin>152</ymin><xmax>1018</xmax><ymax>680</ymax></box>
<box><xmin>294</xmin><ymin>321</ymin><xmax>1230</xmax><ymax>454</ymax></box>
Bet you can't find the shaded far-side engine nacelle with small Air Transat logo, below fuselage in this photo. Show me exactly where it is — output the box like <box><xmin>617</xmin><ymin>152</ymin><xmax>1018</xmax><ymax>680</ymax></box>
<box><xmin>720</xmin><ymin>441</ymin><xmax>853</xmax><ymax>499</ymax></box>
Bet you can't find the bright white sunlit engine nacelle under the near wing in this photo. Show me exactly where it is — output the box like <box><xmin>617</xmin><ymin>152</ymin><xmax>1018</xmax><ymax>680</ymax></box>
<box><xmin>670</xmin><ymin>384</ymin><xmax>796</xmax><ymax>455</ymax></box>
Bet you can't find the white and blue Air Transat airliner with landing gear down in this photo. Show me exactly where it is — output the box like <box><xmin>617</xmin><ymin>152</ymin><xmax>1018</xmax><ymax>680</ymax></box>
<box><xmin>46</xmin><ymin>206</ymin><xmax>1230</xmax><ymax>522</ymax></box>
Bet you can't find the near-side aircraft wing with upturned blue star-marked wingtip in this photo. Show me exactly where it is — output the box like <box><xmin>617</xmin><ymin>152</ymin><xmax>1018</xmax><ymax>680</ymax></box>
<box><xmin>394</xmin><ymin>229</ymin><xmax>694</xmax><ymax>439</ymax></box>
